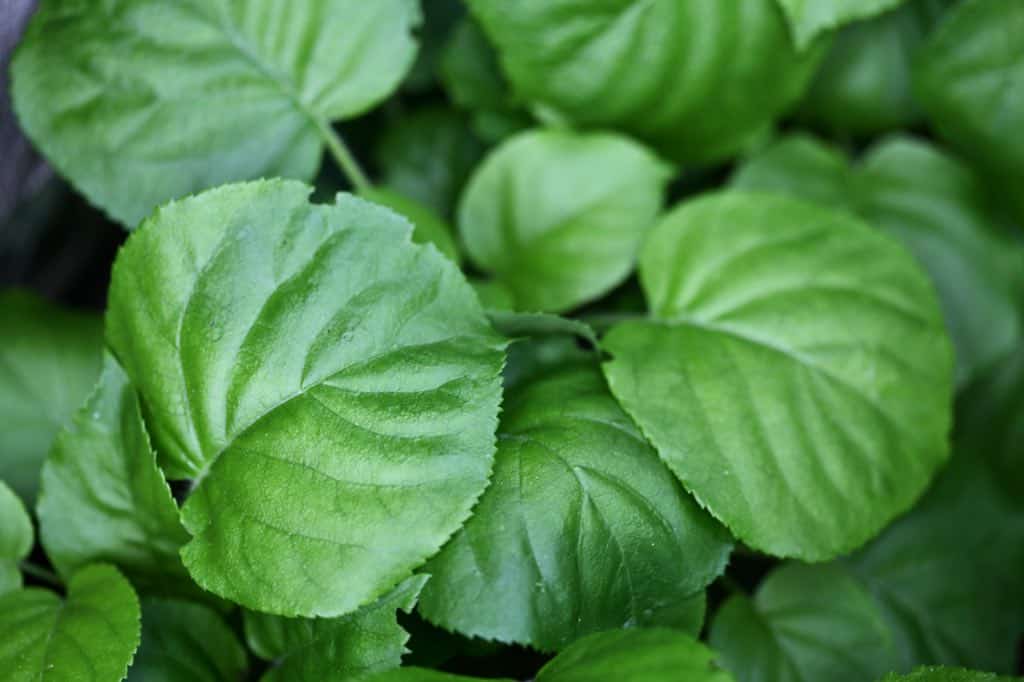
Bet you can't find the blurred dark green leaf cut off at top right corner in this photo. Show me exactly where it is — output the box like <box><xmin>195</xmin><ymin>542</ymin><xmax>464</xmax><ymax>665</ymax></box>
<box><xmin>914</xmin><ymin>0</ymin><xmax>1024</xmax><ymax>182</ymax></box>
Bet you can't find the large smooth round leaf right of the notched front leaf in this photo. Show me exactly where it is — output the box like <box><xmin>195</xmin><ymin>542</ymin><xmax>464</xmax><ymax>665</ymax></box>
<box><xmin>603</xmin><ymin>193</ymin><xmax>952</xmax><ymax>560</ymax></box>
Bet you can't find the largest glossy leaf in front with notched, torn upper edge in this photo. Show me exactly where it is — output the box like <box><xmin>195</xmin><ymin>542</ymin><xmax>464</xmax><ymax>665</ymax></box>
<box><xmin>106</xmin><ymin>180</ymin><xmax>504</xmax><ymax>616</ymax></box>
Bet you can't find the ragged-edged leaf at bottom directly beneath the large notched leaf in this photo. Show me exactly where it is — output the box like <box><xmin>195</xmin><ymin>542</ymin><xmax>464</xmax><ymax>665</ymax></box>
<box><xmin>245</xmin><ymin>576</ymin><xmax>428</xmax><ymax>682</ymax></box>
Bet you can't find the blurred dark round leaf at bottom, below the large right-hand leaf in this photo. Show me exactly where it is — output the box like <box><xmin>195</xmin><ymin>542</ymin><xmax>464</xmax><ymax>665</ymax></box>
<box><xmin>710</xmin><ymin>563</ymin><xmax>895</xmax><ymax>682</ymax></box>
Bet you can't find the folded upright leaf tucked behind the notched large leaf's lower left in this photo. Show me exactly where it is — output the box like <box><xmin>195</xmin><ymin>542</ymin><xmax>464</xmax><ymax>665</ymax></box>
<box><xmin>38</xmin><ymin>355</ymin><xmax>196</xmax><ymax>595</ymax></box>
